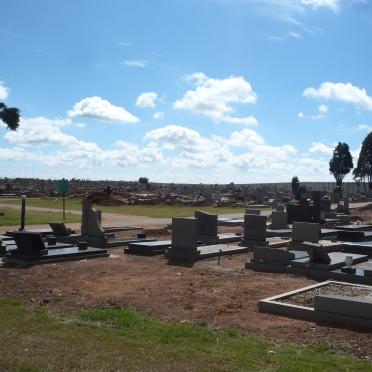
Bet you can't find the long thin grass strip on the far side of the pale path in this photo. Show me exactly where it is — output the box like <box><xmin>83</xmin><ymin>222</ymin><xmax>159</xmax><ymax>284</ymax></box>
<box><xmin>0</xmin><ymin>197</ymin><xmax>250</xmax><ymax>218</ymax></box>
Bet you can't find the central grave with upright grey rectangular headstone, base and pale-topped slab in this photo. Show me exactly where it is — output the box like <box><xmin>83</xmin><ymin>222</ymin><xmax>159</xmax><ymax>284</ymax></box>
<box><xmin>166</xmin><ymin>217</ymin><xmax>247</xmax><ymax>261</ymax></box>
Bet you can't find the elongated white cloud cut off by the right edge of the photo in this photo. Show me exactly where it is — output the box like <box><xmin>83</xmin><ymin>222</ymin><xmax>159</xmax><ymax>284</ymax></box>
<box><xmin>303</xmin><ymin>82</ymin><xmax>372</xmax><ymax>110</ymax></box>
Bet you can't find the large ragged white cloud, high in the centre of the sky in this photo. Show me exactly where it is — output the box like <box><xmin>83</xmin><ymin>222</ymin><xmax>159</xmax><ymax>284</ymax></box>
<box><xmin>174</xmin><ymin>72</ymin><xmax>257</xmax><ymax>125</ymax></box>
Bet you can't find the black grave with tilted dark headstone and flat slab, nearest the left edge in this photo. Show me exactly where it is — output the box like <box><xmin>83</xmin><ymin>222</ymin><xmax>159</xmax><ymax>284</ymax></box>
<box><xmin>3</xmin><ymin>231</ymin><xmax>108</xmax><ymax>267</ymax></box>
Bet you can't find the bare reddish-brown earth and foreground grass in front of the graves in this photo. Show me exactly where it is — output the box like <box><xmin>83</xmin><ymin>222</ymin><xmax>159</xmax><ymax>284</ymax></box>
<box><xmin>0</xmin><ymin>211</ymin><xmax>372</xmax><ymax>371</ymax></box>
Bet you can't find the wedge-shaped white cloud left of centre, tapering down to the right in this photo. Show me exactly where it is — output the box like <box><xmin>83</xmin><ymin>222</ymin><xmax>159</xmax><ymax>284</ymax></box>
<box><xmin>67</xmin><ymin>97</ymin><xmax>139</xmax><ymax>124</ymax></box>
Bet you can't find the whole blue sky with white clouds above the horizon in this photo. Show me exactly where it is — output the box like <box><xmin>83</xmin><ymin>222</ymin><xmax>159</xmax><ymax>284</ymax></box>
<box><xmin>0</xmin><ymin>0</ymin><xmax>372</xmax><ymax>183</ymax></box>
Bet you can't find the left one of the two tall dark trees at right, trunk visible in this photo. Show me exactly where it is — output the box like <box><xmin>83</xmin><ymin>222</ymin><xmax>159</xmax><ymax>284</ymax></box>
<box><xmin>329</xmin><ymin>142</ymin><xmax>354</xmax><ymax>194</ymax></box>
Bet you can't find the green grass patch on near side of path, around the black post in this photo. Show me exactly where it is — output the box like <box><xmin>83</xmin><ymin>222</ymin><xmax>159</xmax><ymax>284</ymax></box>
<box><xmin>0</xmin><ymin>208</ymin><xmax>81</xmax><ymax>227</ymax></box>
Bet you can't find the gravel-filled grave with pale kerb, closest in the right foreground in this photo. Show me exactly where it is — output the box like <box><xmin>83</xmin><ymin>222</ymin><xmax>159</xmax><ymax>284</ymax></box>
<box><xmin>258</xmin><ymin>280</ymin><xmax>372</xmax><ymax>329</ymax></box>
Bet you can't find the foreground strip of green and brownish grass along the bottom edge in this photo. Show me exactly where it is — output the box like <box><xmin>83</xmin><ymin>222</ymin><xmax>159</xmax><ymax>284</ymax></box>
<box><xmin>0</xmin><ymin>299</ymin><xmax>372</xmax><ymax>371</ymax></box>
